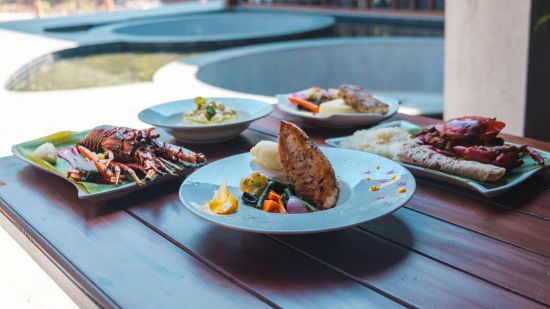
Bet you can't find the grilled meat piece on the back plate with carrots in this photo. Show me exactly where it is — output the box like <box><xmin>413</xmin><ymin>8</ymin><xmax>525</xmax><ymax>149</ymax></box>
<box><xmin>338</xmin><ymin>85</ymin><xmax>389</xmax><ymax>115</ymax></box>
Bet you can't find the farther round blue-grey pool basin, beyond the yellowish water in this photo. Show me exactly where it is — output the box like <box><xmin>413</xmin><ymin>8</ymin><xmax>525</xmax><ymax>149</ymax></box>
<box><xmin>89</xmin><ymin>12</ymin><xmax>335</xmax><ymax>47</ymax></box>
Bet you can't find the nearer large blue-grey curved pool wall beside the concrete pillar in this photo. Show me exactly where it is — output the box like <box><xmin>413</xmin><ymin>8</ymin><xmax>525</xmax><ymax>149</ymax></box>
<box><xmin>184</xmin><ymin>38</ymin><xmax>443</xmax><ymax>115</ymax></box>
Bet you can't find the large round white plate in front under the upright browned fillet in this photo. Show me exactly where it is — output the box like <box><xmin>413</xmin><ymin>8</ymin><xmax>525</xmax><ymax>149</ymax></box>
<box><xmin>179</xmin><ymin>147</ymin><xmax>416</xmax><ymax>234</ymax></box>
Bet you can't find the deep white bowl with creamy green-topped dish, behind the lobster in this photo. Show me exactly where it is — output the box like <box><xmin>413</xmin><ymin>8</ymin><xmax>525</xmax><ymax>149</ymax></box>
<box><xmin>138</xmin><ymin>98</ymin><xmax>273</xmax><ymax>144</ymax></box>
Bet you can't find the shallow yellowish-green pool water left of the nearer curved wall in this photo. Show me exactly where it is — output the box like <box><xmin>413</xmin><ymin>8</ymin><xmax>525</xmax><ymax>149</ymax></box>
<box><xmin>10</xmin><ymin>52</ymin><xmax>199</xmax><ymax>91</ymax></box>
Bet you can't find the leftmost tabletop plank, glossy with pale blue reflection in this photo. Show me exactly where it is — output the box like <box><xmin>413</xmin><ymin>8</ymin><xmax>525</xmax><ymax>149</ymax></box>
<box><xmin>0</xmin><ymin>157</ymin><xmax>267</xmax><ymax>307</ymax></box>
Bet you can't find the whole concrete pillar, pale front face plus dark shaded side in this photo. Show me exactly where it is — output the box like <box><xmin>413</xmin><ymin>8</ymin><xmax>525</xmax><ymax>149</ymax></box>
<box><xmin>444</xmin><ymin>0</ymin><xmax>550</xmax><ymax>141</ymax></box>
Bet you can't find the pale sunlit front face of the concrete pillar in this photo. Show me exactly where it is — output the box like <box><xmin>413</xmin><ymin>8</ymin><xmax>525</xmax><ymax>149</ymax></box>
<box><xmin>444</xmin><ymin>0</ymin><xmax>531</xmax><ymax>135</ymax></box>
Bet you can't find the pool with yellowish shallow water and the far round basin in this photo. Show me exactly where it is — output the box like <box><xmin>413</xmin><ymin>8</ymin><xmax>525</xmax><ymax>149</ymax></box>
<box><xmin>6</xmin><ymin>12</ymin><xmax>443</xmax><ymax>91</ymax></box>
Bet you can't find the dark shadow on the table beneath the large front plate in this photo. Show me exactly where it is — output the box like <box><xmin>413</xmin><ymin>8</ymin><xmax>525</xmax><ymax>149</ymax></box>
<box><xmin>196</xmin><ymin>215</ymin><xmax>414</xmax><ymax>289</ymax></box>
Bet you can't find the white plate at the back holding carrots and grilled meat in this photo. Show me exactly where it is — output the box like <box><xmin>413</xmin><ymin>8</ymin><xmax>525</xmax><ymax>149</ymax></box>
<box><xmin>277</xmin><ymin>94</ymin><xmax>400</xmax><ymax>128</ymax></box>
